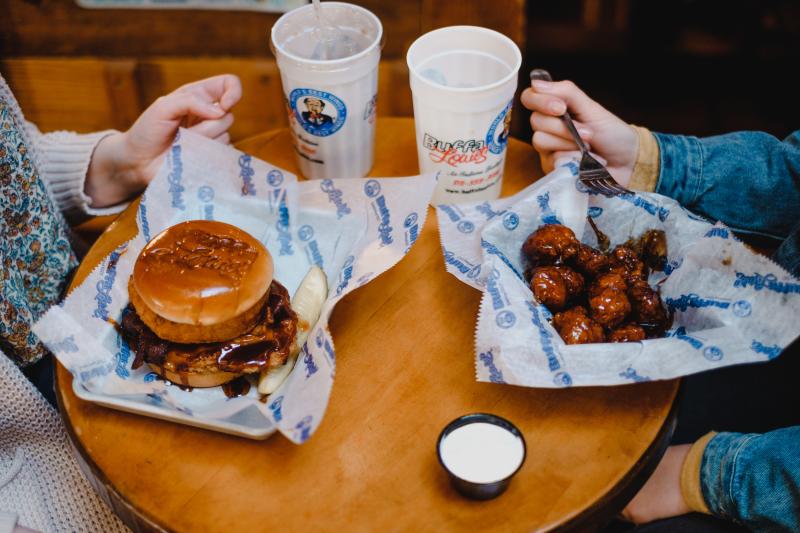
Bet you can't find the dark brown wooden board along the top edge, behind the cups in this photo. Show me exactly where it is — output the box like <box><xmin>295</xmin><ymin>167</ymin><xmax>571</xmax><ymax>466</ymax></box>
<box><xmin>0</xmin><ymin>0</ymin><xmax>424</xmax><ymax>58</ymax></box>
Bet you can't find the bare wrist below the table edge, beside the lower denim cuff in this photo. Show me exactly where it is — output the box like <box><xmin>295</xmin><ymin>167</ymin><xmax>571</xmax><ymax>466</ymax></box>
<box><xmin>622</xmin><ymin>444</ymin><xmax>691</xmax><ymax>524</ymax></box>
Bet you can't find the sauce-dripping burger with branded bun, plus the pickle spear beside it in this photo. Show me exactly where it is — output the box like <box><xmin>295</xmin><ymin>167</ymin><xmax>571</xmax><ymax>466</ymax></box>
<box><xmin>121</xmin><ymin>220</ymin><xmax>327</xmax><ymax>394</ymax></box>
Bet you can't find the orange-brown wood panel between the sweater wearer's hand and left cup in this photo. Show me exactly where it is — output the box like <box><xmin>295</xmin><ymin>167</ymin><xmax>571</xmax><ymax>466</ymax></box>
<box><xmin>137</xmin><ymin>58</ymin><xmax>287</xmax><ymax>142</ymax></box>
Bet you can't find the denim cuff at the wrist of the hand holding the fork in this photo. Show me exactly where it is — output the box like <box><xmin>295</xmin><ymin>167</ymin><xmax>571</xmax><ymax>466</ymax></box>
<box><xmin>653</xmin><ymin>133</ymin><xmax>703</xmax><ymax>208</ymax></box>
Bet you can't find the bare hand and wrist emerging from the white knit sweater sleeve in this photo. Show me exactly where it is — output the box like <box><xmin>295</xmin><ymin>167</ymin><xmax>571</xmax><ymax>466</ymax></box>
<box><xmin>84</xmin><ymin>74</ymin><xmax>242</xmax><ymax>207</ymax></box>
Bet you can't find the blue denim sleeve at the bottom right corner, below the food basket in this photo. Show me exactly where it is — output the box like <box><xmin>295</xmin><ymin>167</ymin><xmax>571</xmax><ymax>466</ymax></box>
<box><xmin>700</xmin><ymin>426</ymin><xmax>800</xmax><ymax>531</ymax></box>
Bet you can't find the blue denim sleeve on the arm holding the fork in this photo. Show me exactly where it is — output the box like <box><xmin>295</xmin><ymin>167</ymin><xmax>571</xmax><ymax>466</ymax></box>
<box><xmin>653</xmin><ymin>132</ymin><xmax>800</xmax><ymax>239</ymax></box>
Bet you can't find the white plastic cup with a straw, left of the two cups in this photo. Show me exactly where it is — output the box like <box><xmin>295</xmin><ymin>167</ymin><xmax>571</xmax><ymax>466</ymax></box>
<box><xmin>271</xmin><ymin>2</ymin><xmax>383</xmax><ymax>179</ymax></box>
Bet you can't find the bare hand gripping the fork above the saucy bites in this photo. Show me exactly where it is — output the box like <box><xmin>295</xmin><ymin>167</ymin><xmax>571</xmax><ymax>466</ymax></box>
<box><xmin>520</xmin><ymin>80</ymin><xmax>639</xmax><ymax>187</ymax></box>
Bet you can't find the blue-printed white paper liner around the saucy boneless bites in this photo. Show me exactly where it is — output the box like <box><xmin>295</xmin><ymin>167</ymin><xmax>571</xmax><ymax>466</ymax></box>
<box><xmin>437</xmin><ymin>163</ymin><xmax>800</xmax><ymax>388</ymax></box>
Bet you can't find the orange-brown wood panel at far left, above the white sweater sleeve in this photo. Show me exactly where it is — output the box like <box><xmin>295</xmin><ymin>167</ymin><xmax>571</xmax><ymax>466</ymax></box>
<box><xmin>0</xmin><ymin>58</ymin><xmax>139</xmax><ymax>132</ymax></box>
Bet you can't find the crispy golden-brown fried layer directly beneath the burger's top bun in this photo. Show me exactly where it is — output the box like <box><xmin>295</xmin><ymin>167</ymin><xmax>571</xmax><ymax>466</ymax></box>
<box><xmin>128</xmin><ymin>276</ymin><xmax>269</xmax><ymax>342</ymax></box>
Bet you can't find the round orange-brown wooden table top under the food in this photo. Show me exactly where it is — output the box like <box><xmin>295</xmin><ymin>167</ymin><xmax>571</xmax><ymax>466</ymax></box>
<box><xmin>57</xmin><ymin>118</ymin><xmax>678</xmax><ymax>532</ymax></box>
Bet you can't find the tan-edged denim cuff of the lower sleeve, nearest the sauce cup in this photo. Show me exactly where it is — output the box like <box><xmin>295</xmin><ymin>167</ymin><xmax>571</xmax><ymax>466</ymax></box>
<box><xmin>700</xmin><ymin>433</ymin><xmax>758</xmax><ymax>520</ymax></box>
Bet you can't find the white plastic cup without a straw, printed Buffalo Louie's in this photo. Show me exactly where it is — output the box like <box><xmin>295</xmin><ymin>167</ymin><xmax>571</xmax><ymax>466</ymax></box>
<box><xmin>406</xmin><ymin>26</ymin><xmax>522</xmax><ymax>204</ymax></box>
